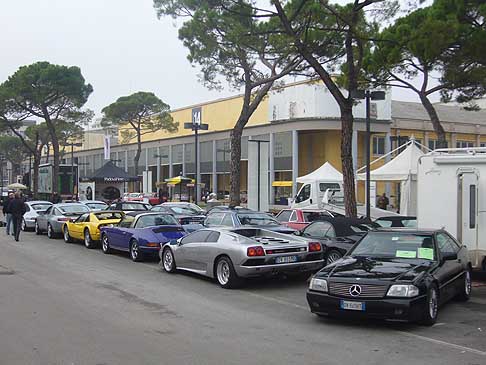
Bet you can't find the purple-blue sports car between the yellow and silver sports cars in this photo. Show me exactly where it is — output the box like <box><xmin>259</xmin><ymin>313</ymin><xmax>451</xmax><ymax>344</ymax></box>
<box><xmin>100</xmin><ymin>212</ymin><xmax>187</xmax><ymax>261</ymax></box>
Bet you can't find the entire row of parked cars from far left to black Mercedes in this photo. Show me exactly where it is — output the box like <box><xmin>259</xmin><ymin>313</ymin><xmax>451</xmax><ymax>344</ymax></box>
<box><xmin>22</xmin><ymin>202</ymin><xmax>472</xmax><ymax>325</ymax></box>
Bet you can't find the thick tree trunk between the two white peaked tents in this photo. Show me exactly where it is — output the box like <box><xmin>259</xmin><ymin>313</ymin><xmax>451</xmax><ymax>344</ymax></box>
<box><xmin>341</xmin><ymin>105</ymin><xmax>357</xmax><ymax>217</ymax></box>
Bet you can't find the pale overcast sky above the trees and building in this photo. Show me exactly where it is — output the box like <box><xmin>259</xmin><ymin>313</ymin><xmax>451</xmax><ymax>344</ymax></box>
<box><xmin>0</xmin><ymin>0</ymin><xmax>432</xmax><ymax>115</ymax></box>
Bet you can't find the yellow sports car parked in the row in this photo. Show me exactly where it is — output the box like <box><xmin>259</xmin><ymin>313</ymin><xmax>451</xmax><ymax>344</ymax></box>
<box><xmin>62</xmin><ymin>210</ymin><xmax>125</xmax><ymax>248</ymax></box>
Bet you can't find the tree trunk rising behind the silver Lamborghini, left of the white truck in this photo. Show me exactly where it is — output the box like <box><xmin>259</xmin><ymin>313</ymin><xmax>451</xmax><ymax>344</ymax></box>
<box><xmin>230</xmin><ymin>123</ymin><xmax>246</xmax><ymax>207</ymax></box>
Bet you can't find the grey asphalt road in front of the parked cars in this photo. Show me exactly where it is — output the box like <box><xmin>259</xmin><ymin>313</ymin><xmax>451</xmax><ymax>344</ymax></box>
<box><xmin>0</xmin><ymin>230</ymin><xmax>486</xmax><ymax>365</ymax></box>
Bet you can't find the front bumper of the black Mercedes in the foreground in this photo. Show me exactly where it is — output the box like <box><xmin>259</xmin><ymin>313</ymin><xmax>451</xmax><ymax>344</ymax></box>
<box><xmin>307</xmin><ymin>290</ymin><xmax>427</xmax><ymax>321</ymax></box>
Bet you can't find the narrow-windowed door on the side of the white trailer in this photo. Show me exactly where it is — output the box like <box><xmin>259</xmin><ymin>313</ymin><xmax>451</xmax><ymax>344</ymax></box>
<box><xmin>457</xmin><ymin>169</ymin><xmax>479</xmax><ymax>250</ymax></box>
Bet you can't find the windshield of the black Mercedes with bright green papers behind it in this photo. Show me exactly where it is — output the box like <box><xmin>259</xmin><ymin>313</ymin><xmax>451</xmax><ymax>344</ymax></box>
<box><xmin>349</xmin><ymin>232</ymin><xmax>435</xmax><ymax>260</ymax></box>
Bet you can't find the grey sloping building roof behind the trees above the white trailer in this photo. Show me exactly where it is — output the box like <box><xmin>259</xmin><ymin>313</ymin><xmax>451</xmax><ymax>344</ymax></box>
<box><xmin>392</xmin><ymin>100</ymin><xmax>486</xmax><ymax>125</ymax></box>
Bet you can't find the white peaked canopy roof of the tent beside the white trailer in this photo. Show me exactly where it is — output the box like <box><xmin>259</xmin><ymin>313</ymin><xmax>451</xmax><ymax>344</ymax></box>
<box><xmin>357</xmin><ymin>140</ymin><xmax>424</xmax><ymax>181</ymax></box>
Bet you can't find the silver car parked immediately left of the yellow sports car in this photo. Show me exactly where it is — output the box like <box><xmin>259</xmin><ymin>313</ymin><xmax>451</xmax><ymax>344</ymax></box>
<box><xmin>35</xmin><ymin>203</ymin><xmax>90</xmax><ymax>238</ymax></box>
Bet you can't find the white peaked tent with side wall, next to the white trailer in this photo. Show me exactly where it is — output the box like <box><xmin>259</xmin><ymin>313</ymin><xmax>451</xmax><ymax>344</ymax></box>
<box><xmin>356</xmin><ymin>138</ymin><xmax>424</xmax><ymax>215</ymax></box>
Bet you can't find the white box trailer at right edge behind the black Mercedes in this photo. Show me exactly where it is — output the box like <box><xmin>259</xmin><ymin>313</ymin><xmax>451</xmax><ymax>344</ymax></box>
<box><xmin>417</xmin><ymin>148</ymin><xmax>486</xmax><ymax>270</ymax></box>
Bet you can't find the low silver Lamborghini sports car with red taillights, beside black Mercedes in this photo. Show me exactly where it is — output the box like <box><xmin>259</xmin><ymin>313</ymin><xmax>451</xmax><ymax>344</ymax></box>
<box><xmin>159</xmin><ymin>228</ymin><xmax>324</xmax><ymax>288</ymax></box>
